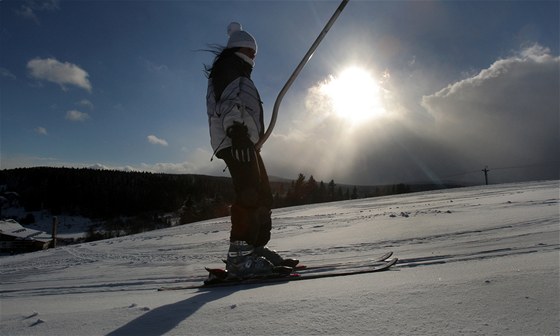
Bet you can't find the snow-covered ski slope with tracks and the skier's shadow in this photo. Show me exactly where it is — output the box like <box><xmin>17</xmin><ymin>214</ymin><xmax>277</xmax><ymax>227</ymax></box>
<box><xmin>0</xmin><ymin>181</ymin><xmax>560</xmax><ymax>336</ymax></box>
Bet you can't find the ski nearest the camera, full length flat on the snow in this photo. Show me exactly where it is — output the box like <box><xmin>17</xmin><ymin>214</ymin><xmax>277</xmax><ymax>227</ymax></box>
<box><xmin>158</xmin><ymin>258</ymin><xmax>398</xmax><ymax>291</ymax></box>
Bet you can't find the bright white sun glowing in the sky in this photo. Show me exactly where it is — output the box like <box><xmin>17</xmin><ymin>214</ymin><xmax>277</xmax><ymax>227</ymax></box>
<box><xmin>321</xmin><ymin>66</ymin><xmax>385</xmax><ymax>124</ymax></box>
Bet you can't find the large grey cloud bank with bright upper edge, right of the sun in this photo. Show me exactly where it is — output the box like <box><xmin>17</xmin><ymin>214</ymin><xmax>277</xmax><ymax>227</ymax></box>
<box><xmin>422</xmin><ymin>45</ymin><xmax>560</xmax><ymax>184</ymax></box>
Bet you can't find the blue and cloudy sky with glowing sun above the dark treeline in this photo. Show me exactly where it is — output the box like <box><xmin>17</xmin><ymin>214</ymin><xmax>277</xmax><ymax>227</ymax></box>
<box><xmin>0</xmin><ymin>0</ymin><xmax>560</xmax><ymax>185</ymax></box>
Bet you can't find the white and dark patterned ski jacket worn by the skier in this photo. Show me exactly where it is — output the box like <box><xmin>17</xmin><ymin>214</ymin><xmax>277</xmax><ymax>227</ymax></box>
<box><xmin>206</xmin><ymin>53</ymin><xmax>264</xmax><ymax>157</ymax></box>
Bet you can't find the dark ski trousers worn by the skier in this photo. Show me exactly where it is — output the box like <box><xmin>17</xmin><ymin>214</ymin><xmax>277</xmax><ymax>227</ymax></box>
<box><xmin>218</xmin><ymin>148</ymin><xmax>273</xmax><ymax>246</ymax></box>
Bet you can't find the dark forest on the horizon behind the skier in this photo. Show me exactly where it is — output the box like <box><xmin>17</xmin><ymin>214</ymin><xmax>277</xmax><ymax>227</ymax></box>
<box><xmin>0</xmin><ymin>167</ymin><xmax>456</xmax><ymax>236</ymax></box>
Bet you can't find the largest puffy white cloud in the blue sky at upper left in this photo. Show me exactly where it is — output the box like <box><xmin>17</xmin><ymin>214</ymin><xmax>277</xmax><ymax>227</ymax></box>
<box><xmin>27</xmin><ymin>58</ymin><xmax>92</xmax><ymax>92</ymax></box>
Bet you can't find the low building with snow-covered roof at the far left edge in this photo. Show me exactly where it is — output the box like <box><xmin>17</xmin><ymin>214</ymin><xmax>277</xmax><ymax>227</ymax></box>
<box><xmin>0</xmin><ymin>219</ymin><xmax>51</xmax><ymax>253</ymax></box>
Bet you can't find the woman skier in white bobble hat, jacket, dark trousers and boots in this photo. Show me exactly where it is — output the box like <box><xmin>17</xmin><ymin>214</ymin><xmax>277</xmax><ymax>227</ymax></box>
<box><xmin>205</xmin><ymin>22</ymin><xmax>299</xmax><ymax>279</ymax></box>
